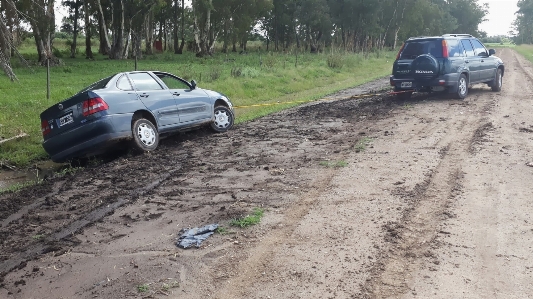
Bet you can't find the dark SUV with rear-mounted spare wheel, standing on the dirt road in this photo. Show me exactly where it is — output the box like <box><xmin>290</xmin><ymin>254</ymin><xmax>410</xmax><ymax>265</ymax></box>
<box><xmin>390</xmin><ymin>34</ymin><xmax>505</xmax><ymax>99</ymax></box>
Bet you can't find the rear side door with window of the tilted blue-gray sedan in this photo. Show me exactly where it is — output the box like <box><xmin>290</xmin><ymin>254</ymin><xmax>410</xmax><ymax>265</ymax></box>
<box><xmin>128</xmin><ymin>72</ymin><xmax>180</xmax><ymax>127</ymax></box>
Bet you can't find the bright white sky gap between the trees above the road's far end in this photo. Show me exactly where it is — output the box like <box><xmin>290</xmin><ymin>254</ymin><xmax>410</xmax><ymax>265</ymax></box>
<box><xmin>479</xmin><ymin>0</ymin><xmax>518</xmax><ymax>36</ymax></box>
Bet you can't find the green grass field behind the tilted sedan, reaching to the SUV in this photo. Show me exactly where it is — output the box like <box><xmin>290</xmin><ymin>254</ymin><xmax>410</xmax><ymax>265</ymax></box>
<box><xmin>0</xmin><ymin>39</ymin><xmax>396</xmax><ymax>166</ymax></box>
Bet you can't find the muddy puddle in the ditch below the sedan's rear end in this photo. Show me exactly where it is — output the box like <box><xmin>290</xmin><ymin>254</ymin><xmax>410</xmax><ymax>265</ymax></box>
<box><xmin>0</xmin><ymin>161</ymin><xmax>66</xmax><ymax>190</ymax></box>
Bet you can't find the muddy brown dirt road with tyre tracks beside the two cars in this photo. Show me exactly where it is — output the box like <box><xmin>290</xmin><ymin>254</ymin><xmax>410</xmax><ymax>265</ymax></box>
<box><xmin>0</xmin><ymin>49</ymin><xmax>533</xmax><ymax>299</ymax></box>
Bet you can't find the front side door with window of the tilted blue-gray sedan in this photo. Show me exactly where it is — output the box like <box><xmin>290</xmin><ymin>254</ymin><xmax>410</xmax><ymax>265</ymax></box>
<box><xmin>154</xmin><ymin>72</ymin><xmax>213</xmax><ymax>125</ymax></box>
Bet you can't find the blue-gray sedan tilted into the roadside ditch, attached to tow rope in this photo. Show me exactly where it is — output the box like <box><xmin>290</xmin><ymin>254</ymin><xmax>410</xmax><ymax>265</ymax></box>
<box><xmin>41</xmin><ymin>71</ymin><xmax>235</xmax><ymax>162</ymax></box>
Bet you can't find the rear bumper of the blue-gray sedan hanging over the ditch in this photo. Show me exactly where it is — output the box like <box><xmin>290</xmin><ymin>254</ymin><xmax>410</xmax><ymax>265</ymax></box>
<box><xmin>43</xmin><ymin>114</ymin><xmax>132</xmax><ymax>162</ymax></box>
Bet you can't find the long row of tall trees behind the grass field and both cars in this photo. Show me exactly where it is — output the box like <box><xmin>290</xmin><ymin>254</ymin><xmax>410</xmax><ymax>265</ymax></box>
<box><xmin>0</xmin><ymin>0</ymin><xmax>488</xmax><ymax>76</ymax></box>
